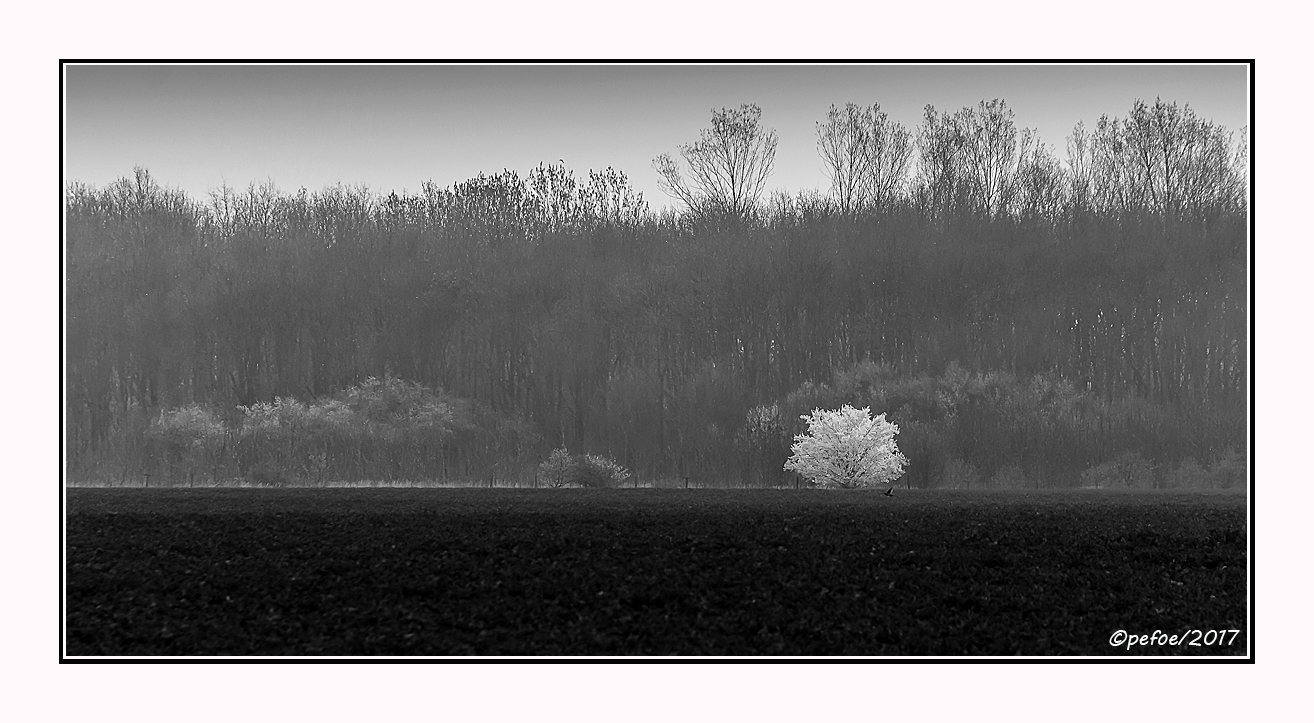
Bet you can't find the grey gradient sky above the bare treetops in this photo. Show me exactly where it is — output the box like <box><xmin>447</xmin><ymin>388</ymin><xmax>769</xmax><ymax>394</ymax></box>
<box><xmin>63</xmin><ymin>64</ymin><xmax>1250</xmax><ymax>209</ymax></box>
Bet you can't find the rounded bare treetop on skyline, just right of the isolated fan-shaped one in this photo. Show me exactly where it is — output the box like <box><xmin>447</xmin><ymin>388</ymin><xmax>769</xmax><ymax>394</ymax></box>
<box><xmin>817</xmin><ymin>103</ymin><xmax>912</xmax><ymax>213</ymax></box>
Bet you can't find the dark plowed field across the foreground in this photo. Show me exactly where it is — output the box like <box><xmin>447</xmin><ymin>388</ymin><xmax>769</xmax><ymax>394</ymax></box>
<box><xmin>64</xmin><ymin>489</ymin><xmax>1248</xmax><ymax>656</ymax></box>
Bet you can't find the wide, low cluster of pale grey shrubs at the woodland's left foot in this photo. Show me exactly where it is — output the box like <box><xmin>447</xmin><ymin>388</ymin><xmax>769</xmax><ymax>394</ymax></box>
<box><xmin>137</xmin><ymin>375</ymin><xmax>537</xmax><ymax>486</ymax></box>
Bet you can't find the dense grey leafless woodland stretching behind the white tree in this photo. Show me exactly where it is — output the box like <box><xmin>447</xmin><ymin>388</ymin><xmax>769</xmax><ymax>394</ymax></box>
<box><xmin>64</xmin><ymin>96</ymin><xmax>1250</xmax><ymax>486</ymax></box>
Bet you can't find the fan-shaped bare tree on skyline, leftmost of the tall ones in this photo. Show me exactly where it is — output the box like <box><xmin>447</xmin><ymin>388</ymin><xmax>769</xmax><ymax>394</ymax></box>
<box><xmin>653</xmin><ymin>104</ymin><xmax>777</xmax><ymax>217</ymax></box>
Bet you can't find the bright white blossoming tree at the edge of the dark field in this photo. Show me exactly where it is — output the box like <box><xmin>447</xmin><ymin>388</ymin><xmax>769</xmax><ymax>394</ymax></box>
<box><xmin>784</xmin><ymin>405</ymin><xmax>908</xmax><ymax>489</ymax></box>
